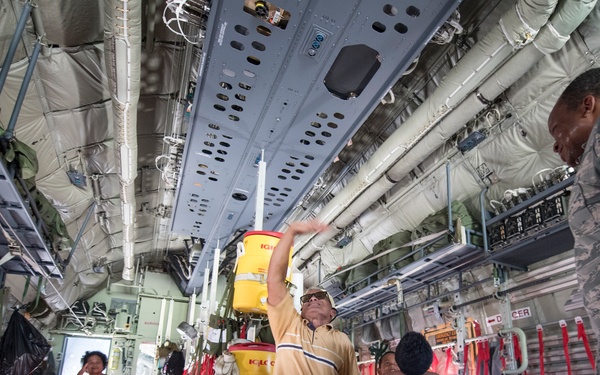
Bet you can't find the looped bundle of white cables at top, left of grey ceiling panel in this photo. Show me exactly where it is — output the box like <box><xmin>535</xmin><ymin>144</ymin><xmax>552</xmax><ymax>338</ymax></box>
<box><xmin>163</xmin><ymin>0</ymin><xmax>210</xmax><ymax>44</ymax></box>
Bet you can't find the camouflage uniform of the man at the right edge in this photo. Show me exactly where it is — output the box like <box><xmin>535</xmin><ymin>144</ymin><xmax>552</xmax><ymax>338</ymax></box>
<box><xmin>569</xmin><ymin>120</ymin><xmax>600</xmax><ymax>374</ymax></box>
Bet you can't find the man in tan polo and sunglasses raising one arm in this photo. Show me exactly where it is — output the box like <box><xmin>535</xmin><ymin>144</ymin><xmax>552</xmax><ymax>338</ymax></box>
<box><xmin>267</xmin><ymin>220</ymin><xmax>359</xmax><ymax>375</ymax></box>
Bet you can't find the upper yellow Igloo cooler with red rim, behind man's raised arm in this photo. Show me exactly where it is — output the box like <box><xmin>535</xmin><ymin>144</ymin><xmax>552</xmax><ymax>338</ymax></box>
<box><xmin>233</xmin><ymin>231</ymin><xmax>292</xmax><ymax>314</ymax></box>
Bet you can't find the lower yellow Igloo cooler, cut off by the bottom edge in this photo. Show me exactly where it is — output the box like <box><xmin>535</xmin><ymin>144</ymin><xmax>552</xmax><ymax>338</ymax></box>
<box><xmin>227</xmin><ymin>342</ymin><xmax>275</xmax><ymax>375</ymax></box>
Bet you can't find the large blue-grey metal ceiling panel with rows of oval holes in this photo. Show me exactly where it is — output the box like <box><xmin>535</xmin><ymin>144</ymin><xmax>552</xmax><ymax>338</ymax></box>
<box><xmin>172</xmin><ymin>0</ymin><xmax>459</xmax><ymax>293</ymax></box>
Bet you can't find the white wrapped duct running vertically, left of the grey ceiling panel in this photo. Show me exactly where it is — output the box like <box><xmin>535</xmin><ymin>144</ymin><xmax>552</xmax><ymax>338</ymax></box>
<box><xmin>104</xmin><ymin>0</ymin><xmax>142</xmax><ymax>280</ymax></box>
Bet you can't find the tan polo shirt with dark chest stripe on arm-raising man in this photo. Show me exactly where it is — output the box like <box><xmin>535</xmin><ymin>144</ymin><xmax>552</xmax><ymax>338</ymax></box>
<box><xmin>267</xmin><ymin>295</ymin><xmax>359</xmax><ymax>375</ymax></box>
